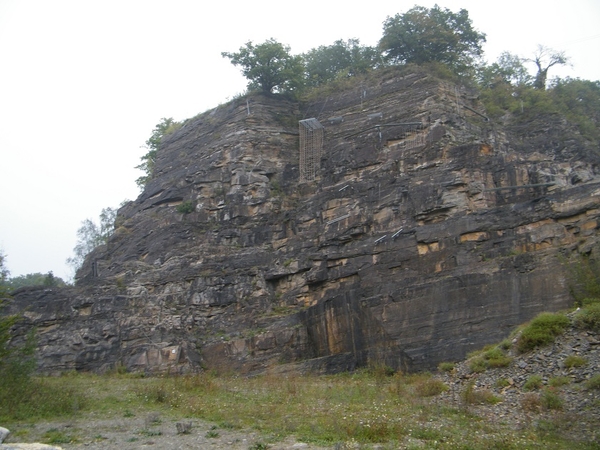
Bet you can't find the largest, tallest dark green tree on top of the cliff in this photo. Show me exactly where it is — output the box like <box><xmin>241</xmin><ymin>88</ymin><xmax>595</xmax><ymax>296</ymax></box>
<box><xmin>379</xmin><ymin>5</ymin><xmax>485</xmax><ymax>74</ymax></box>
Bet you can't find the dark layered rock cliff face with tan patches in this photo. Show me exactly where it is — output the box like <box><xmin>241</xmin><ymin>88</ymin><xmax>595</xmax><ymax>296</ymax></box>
<box><xmin>12</xmin><ymin>67</ymin><xmax>600</xmax><ymax>373</ymax></box>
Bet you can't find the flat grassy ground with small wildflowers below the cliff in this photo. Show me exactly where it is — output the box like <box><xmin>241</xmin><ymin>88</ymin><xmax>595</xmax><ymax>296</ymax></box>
<box><xmin>0</xmin><ymin>369</ymin><xmax>594</xmax><ymax>449</ymax></box>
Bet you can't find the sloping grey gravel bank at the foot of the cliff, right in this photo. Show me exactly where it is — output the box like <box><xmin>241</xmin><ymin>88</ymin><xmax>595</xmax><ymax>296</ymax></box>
<box><xmin>435</xmin><ymin>322</ymin><xmax>600</xmax><ymax>448</ymax></box>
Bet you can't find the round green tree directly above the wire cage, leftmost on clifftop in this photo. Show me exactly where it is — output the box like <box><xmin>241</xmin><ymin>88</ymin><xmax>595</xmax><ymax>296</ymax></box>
<box><xmin>221</xmin><ymin>38</ymin><xmax>304</xmax><ymax>94</ymax></box>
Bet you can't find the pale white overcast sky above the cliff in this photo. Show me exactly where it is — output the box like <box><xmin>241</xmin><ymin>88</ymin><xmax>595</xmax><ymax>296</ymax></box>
<box><xmin>0</xmin><ymin>0</ymin><xmax>600</xmax><ymax>279</ymax></box>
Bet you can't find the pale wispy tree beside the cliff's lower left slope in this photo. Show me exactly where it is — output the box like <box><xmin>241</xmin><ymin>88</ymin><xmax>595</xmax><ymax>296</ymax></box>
<box><xmin>67</xmin><ymin>208</ymin><xmax>117</xmax><ymax>273</ymax></box>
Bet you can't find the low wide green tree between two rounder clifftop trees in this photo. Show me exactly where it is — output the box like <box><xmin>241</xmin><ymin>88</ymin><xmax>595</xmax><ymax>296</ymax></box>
<box><xmin>303</xmin><ymin>39</ymin><xmax>382</xmax><ymax>86</ymax></box>
